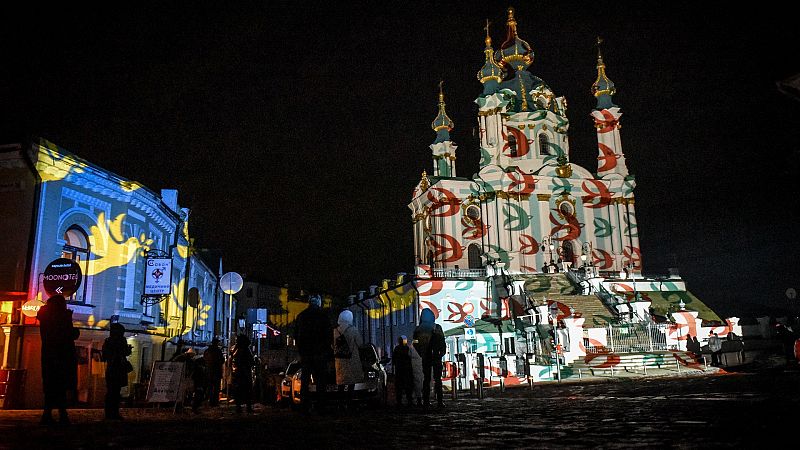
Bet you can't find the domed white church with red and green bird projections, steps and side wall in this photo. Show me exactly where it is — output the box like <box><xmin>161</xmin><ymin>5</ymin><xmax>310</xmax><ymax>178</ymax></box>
<box><xmin>350</xmin><ymin>9</ymin><xmax>736</xmax><ymax>378</ymax></box>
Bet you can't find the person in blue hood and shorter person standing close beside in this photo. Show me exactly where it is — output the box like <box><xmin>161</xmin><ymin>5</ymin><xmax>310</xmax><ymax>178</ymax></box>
<box><xmin>392</xmin><ymin>308</ymin><xmax>447</xmax><ymax>407</ymax></box>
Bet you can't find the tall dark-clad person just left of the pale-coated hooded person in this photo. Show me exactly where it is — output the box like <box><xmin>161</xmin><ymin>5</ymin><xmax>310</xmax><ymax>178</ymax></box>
<box><xmin>294</xmin><ymin>294</ymin><xmax>332</xmax><ymax>412</ymax></box>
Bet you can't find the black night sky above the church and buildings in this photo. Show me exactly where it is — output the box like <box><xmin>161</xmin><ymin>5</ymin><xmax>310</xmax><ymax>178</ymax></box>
<box><xmin>0</xmin><ymin>1</ymin><xmax>800</xmax><ymax>315</ymax></box>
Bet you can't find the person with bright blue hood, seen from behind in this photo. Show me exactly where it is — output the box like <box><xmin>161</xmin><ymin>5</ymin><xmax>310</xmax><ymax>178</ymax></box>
<box><xmin>414</xmin><ymin>308</ymin><xmax>447</xmax><ymax>408</ymax></box>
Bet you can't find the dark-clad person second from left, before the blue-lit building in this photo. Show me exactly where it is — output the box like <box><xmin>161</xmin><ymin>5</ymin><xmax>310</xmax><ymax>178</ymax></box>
<box><xmin>102</xmin><ymin>323</ymin><xmax>133</xmax><ymax>420</ymax></box>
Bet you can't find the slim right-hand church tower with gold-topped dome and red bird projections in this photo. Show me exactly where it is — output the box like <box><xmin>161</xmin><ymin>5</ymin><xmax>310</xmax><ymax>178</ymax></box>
<box><xmin>591</xmin><ymin>38</ymin><xmax>628</xmax><ymax>179</ymax></box>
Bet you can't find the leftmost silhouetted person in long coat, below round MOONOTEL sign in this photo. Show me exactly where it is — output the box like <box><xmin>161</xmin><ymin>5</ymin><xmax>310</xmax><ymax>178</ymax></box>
<box><xmin>36</xmin><ymin>295</ymin><xmax>80</xmax><ymax>425</ymax></box>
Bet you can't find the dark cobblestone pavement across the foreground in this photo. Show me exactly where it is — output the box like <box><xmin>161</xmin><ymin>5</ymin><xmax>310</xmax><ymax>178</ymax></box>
<box><xmin>0</xmin><ymin>367</ymin><xmax>800</xmax><ymax>449</ymax></box>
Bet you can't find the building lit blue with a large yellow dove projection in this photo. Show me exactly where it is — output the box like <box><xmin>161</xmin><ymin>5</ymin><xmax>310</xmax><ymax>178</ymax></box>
<box><xmin>0</xmin><ymin>139</ymin><xmax>225</xmax><ymax>408</ymax></box>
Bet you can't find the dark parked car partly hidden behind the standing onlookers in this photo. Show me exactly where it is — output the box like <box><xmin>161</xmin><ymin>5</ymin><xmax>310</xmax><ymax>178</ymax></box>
<box><xmin>291</xmin><ymin>344</ymin><xmax>387</xmax><ymax>405</ymax></box>
